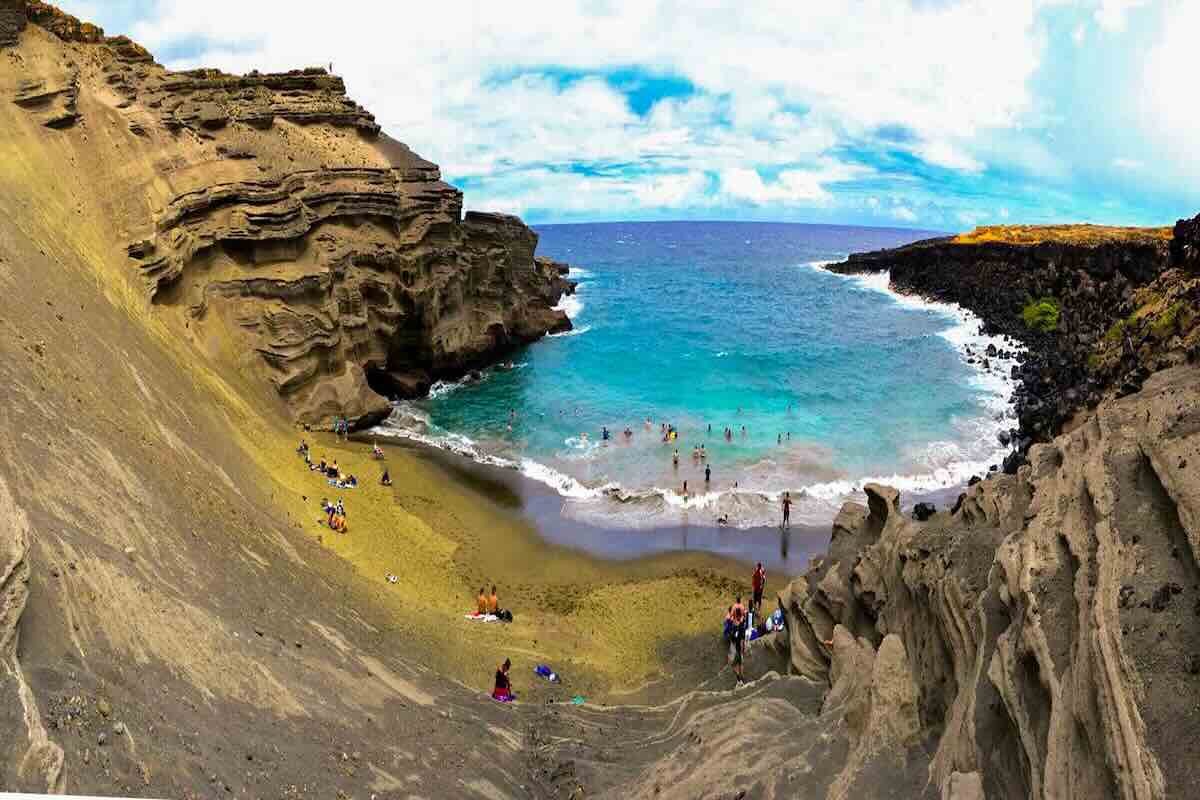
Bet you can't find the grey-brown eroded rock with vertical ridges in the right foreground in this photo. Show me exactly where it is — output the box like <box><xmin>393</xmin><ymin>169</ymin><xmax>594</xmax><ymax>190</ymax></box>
<box><xmin>780</xmin><ymin>366</ymin><xmax>1200</xmax><ymax>799</ymax></box>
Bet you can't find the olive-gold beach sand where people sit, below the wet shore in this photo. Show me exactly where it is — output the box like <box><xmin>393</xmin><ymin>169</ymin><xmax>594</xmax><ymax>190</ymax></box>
<box><xmin>258</xmin><ymin>432</ymin><xmax>828</xmax><ymax>702</ymax></box>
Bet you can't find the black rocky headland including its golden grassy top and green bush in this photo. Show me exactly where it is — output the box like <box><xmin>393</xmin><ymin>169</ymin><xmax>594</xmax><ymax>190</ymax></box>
<box><xmin>829</xmin><ymin>217</ymin><xmax>1200</xmax><ymax>474</ymax></box>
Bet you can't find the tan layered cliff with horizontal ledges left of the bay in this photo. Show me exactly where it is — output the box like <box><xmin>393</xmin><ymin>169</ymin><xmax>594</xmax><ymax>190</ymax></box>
<box><xmin>0</xmin><ymin>0</ymin><xmax>572</xmax><ymax>425</ymax></box>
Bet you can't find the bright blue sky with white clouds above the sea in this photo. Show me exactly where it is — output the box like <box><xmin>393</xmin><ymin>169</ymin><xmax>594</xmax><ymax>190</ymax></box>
<box><xmin>59</xmin><ymin>0</ymin><xmax>1200</xmax><ymax>230</ymax></box>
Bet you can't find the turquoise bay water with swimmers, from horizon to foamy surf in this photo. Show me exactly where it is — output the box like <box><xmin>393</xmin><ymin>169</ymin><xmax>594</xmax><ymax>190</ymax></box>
<box><xmin>386</xmin><ymin>223</ymin><xmax>1009</xmax><ymax>527</ymax></box>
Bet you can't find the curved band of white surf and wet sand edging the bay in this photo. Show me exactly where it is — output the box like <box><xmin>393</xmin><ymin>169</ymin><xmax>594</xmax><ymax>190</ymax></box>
<box><xmin>355</xmin><ymin>260</ymin><xmax>1024</xmax><ymax>551</ymax></box>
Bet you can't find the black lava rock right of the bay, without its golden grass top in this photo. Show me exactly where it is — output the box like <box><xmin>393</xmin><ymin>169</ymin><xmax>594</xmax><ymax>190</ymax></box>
<box><xmin>827</xmin><ymin>217</ymin><xmax>1200</xmax><ymax>474</ymax></box>
